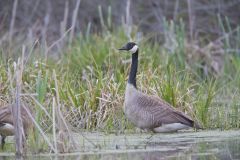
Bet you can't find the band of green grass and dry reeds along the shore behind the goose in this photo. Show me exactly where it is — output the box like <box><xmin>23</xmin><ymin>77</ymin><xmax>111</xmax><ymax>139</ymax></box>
<box><xmin>0</xmin><ymin>0</ymin><xmax>240</xmax><ymax>153</ymax></box>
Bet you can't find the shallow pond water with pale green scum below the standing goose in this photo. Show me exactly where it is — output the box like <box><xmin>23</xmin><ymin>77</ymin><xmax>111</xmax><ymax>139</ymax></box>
<box><xmin>0</xmin><ymin>131</ymin><xmax>240</xmax><ymax>160</ymax></box>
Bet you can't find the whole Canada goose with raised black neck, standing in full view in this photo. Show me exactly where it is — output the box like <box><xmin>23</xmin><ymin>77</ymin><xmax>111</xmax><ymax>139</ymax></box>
<box><xmin>119</xmin><ymin>42</ymin><xmax>200</xmax><ymax>132</ymax></box>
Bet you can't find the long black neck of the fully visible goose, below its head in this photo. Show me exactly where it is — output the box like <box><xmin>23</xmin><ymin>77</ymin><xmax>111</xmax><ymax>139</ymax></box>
<box><xmin>128</xmin><ymin>50</ymin><xmax>138</xmax><ymax>88</ymax></box>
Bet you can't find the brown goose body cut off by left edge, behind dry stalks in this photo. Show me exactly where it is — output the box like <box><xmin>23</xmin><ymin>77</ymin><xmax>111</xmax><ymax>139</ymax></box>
<box><xmin>0</xmin><ymin>105</ymin><xmax>33</xmax><ymax>149</ymax></box>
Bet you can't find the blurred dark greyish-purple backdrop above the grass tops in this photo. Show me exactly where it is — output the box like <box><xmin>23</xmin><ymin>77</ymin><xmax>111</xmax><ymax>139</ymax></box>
<box><xmin>0</xmin><ymin>0</ymin><xmax>240</xmax><ymax>45</ymax></box>
